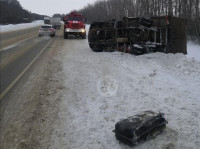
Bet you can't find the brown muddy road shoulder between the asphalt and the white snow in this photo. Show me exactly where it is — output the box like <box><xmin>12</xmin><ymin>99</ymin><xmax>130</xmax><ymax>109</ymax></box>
<box><xmin>0</xmin><ymin>30</ymin><xmax>63</xmax><ymax>149</ymax></box>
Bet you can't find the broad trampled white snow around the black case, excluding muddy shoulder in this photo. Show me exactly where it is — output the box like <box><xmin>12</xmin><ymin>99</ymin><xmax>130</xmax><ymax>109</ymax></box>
<box><xmin>50</xmin><ymin>34</ymin><xmax>200</xmax><ymax>149</ymax></box>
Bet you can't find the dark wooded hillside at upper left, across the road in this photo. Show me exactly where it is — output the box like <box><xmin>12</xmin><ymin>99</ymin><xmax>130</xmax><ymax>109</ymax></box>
<box><xmin>0</xmin><ymin>0</ymin><xmax>47</xmax><ymax>24</ymax></box>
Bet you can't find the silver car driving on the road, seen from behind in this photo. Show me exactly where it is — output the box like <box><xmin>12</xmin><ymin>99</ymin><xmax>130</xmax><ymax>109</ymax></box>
<box><xmin>39</xmin><ymin>24</ymin><xmax>56</xmax><ymax>37</ymax></box>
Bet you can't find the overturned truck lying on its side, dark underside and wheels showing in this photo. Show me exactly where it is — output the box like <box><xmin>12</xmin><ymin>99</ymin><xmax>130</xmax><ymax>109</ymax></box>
<box><xmin>88</xmin><ymin>16</ymin><xmax>187</xmax><ymax>55</ymax></box>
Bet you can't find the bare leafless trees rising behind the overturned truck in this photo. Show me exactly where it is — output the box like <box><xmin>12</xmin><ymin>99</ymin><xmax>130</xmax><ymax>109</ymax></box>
<box><xmin>79</xmin><ymin>0</ymin><xmax>200</xmax><ymax>43</ymax></box>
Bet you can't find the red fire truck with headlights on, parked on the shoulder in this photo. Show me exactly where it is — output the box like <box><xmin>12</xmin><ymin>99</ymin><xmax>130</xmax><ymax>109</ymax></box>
<box><xmin>63</xmin><ymin>12</ymin><xmax>86</xmax><ymax>39</ymax></box>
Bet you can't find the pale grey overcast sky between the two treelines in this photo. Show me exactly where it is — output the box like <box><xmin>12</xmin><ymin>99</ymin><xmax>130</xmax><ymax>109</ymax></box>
<box><xmin>18</xmin><ymin>0</ymin><xmax>97</xmax><ymax>16</ymax></box>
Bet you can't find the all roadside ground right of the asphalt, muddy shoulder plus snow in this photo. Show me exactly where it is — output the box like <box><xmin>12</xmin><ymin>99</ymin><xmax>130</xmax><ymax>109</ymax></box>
<box><xmin>2</xmin><ymin>23</ymin><xmax>200</xmax><ymax>149</ymax></box>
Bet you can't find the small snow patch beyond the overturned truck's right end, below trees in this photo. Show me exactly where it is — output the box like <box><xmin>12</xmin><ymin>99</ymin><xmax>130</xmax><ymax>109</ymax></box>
<box><xmin>187</xmin><ymin>41</ymin><xmax>200</xmax><ymax>61</ymax></box>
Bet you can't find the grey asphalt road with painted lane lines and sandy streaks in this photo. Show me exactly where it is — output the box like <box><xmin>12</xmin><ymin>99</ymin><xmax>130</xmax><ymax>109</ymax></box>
<box><xmin>0</xmin><ymin>27</ymin><xmax>59</xmax><ymax>98</ymax></box>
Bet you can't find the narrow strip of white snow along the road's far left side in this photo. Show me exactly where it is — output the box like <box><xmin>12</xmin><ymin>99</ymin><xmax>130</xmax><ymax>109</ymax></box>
<box><xmin>0</xmin><ymin>20</ymin><xmax>44</xmax><ymax>33</ymax></box>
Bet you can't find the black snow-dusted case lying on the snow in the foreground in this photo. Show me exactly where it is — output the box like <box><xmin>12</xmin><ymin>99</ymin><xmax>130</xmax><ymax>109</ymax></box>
<box><xmin>114</xmin><ymin>111</ymin><xmax>167</xmax><ymax>146</ymax></box>
